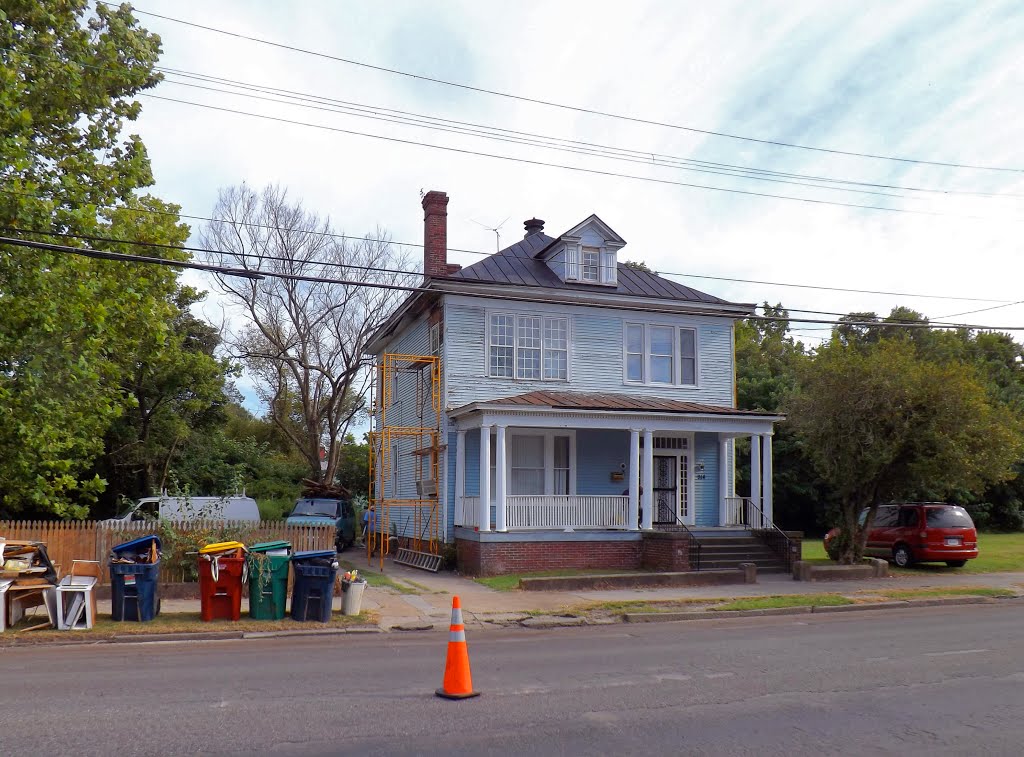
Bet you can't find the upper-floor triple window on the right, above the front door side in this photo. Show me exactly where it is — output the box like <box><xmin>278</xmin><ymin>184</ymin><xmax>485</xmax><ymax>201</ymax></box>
<box><xmin>624</xmin><ymin>324</ymin><xmax>697</xmax><ymax>386</ymax></box>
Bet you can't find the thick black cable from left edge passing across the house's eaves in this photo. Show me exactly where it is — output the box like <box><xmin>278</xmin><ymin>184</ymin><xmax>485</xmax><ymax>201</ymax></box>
<box><xmin>8</xmin><ymin>237</ymin><xmax>1024</xmax><ymax>331</ymax></box>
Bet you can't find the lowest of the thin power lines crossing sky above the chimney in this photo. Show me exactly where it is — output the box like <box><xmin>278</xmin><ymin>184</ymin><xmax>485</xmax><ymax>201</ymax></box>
<box><xmin>146</xmin><ymin>93</ymin><xmax>1024</xmax><ymax>221</ymax></box>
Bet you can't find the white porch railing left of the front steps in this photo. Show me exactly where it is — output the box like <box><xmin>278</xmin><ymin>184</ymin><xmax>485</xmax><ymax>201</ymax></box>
<box><xmin>455</xmin><ymin>494</ymin><xmax>630</xmax><ymax>531</ymax></box>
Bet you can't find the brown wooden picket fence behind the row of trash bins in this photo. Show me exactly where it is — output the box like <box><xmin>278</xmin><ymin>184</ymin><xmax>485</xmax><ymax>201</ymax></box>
<box><xmin>0</xmin><ymin>520</ymin><xmax>335</xmax><ymax>583</ymax></box>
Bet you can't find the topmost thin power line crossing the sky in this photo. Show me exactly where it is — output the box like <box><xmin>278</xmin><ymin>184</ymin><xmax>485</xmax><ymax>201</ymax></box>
<box><xmin>119</xmin><ymin>2</ymin><xmax>1024</xmax><ymax>173</ymax></box>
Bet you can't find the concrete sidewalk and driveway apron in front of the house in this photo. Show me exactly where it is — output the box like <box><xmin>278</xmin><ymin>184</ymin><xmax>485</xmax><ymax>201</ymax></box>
<box><xmin>151</xmin><ymin>554</ymin><xmax>1024</xmax><ymax>630</ymax></box>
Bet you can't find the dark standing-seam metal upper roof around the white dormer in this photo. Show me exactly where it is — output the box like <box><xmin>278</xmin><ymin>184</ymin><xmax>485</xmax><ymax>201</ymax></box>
<box><xmin>444</xmin><ymin>233</ymin><xmax>731</xmax><ymax>304</ymax></box>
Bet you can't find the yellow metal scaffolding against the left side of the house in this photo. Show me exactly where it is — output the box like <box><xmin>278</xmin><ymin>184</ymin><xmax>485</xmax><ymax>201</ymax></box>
<box><xmin>365</xmin><ymin>352</ymin><xmax>441</xmax><ymax>570</ymax></box>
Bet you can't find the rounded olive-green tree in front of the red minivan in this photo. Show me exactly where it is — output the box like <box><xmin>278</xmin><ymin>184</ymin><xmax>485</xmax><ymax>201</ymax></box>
<box><xmin>786</xmin><ymin>338</ymin><xmax>1024</xmax><ymax>562</ymax></box>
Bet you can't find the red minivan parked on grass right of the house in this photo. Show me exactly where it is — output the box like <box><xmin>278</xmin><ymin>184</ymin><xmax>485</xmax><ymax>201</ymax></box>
<box><xmin>824</xmin><ymin>502</ymin><xmax>978</xmax><ymax>567</ymax></box>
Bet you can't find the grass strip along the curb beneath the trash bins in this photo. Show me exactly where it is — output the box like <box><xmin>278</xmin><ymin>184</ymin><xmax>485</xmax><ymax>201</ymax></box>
<box><xmin>0</xmin><ymin>613</ymin><xmax>375</xmax><ymax>646</ymax></box>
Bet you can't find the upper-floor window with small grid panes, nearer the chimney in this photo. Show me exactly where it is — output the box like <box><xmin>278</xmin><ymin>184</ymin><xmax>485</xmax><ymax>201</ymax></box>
<box><xmin>487</xmin><ymin>312</ymin><xmax>569</xmax><ymax>381</ymax></box>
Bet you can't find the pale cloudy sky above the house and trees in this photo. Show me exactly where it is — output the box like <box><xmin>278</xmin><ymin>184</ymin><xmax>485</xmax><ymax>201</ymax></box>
<box><xmin>121</xmin><ymin>0</ymin><xmax>1024</xmax><ymax>408</ymax></box>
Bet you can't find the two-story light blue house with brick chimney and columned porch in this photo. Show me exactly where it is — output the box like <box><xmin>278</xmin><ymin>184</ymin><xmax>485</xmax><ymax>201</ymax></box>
<box><xmin>369</xmin><ymin>192</ymin><xmax>780</xmax><ymax>575</ymax></box>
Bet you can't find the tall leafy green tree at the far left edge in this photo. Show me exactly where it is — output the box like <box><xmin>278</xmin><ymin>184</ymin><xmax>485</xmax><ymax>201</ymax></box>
<box><xmin>0</xmin><ymin>0</ymin><xmax>163</xmax><ymax>517</ymax></box>
